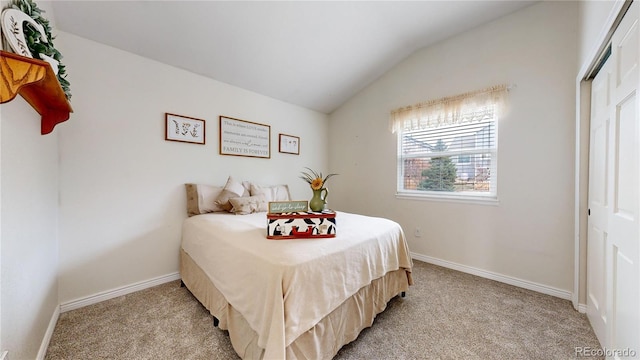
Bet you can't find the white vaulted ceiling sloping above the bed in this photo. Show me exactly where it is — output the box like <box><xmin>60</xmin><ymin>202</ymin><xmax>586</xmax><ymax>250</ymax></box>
<box><xmin>52</xmin><ymin>0</ymin><xmax>543</xmax><ymax>113</ymax></box>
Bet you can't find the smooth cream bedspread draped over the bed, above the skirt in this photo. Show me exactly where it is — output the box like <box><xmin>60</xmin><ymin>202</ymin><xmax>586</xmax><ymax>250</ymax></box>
<box><xmin>182</xmin><ymin>212</ymin><xmax>412</xmax><ymax>359</ymax></box>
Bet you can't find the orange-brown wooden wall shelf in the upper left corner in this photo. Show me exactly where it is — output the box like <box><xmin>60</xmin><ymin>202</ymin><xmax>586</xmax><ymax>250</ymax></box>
<box><xmin>0</xmin><ymin>51</ymin><xmax>73</xmax><ymax>135</ymax></box>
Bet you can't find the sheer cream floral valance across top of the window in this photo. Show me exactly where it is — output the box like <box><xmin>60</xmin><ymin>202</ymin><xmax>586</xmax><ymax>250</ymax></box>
<box><xmin>389</xmin><ymin>85</ymin><xmax>509</xmax><ymax>133</ymax></box>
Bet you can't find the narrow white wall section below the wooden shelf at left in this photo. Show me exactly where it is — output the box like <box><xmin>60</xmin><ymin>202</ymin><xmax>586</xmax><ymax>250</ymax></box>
<box><xmin>0</xmin><ymin>97</ymin><xmax>58</xmax><ymax>359</ymax></box>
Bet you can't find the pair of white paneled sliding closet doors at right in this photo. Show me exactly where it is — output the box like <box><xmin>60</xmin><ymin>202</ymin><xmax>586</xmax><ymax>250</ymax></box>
<box><xmin>587</xmin><ymin>1</ymin><xmax>640</xmax><ymax>359</ymax></box>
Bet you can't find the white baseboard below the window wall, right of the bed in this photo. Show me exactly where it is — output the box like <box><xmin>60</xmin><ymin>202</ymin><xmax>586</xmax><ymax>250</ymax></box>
<box><xmin>411</xmin><ymin>252</ymin><xmax>572</xmax><ymax>300</ymax></box>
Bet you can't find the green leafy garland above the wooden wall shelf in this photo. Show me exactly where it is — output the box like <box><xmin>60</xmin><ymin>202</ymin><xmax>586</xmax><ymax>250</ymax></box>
<box><xmin>11</xmin><ymin>0</ymin><xmax>71</xmax><ymax>99</ymax></box>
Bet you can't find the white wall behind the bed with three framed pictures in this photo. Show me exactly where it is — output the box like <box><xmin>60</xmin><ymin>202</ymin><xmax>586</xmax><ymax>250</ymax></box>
<box><xmin>57</xmin><ymin>32</ymin><xmax>328</xmax><ymax>304</ymax></box>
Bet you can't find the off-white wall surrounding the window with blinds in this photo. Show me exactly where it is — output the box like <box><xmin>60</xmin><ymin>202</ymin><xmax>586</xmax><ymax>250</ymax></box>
<box><xmin>329</xmin><ymin>2</ymin><xmax>578</xmax><ymax>294</ymax></box>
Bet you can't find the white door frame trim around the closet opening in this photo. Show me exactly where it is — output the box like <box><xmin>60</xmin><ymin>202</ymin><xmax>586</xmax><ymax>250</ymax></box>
<box><xmin>571</xmin><ymin>0</ymin><xmax>631</xmax><ymax>313</ymax></box>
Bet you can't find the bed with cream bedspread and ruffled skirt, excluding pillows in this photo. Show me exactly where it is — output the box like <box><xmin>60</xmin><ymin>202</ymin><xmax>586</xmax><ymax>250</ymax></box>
<box><xmin>180</xmin><ymin>212</ymin><xmax>412</xmax><ymax>359</ymax></box>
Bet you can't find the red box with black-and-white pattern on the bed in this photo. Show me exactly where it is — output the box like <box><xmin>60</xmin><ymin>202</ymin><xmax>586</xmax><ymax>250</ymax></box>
<box><xmin>267</xmin><ymin>210</ymin><xmax>336</xmax><ymax>240</ymax></box>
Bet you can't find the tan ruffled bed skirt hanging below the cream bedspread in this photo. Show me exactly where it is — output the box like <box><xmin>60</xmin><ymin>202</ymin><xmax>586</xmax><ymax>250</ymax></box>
<box><xmin>180</xmin><ymin>249</ymin><xmax>409</xmax><ymax>360</ymax></box>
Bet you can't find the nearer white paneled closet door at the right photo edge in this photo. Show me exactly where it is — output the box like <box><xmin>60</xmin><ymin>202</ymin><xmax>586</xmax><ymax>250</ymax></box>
<box><xmin>608</xmin><ymin>1</ymin><xmax>640</xmax><ymax>358</ymax></box>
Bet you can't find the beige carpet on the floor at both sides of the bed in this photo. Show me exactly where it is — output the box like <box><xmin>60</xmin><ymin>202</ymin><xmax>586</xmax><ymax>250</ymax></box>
<box><xmin>46</xmin><ymin>261</ymin><xmax>599</xmax><ymax>360</ymax></box>
